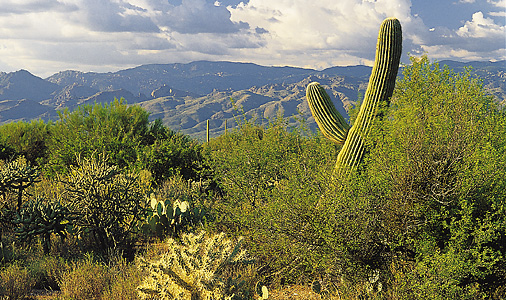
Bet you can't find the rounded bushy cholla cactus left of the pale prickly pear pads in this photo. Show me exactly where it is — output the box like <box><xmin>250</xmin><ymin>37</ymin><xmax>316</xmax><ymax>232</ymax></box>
<box><xmin>65</xmin><ymin>156</ymin><xmax>146</xmax><ymax>250</ymax></box>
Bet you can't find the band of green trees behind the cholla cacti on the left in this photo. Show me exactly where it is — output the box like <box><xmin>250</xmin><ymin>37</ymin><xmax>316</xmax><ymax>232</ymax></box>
<box><xmin>0</xmin><ymin>99</ymin><xmax>206</xmax><ymax>185</ymax></box>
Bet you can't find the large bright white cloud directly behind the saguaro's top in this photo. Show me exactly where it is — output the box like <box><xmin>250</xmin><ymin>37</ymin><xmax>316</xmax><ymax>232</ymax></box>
<box><xmin>229</xmin><ymin>0</ymin><xmax>422</xmax><ymax>66</ymax></box>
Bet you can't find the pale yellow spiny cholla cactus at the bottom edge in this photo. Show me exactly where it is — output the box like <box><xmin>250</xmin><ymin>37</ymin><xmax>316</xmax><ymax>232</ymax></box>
<box><xmin>138</xmin><ymin>231</ymin><xmax>247</xmax><ymax>300</ymax></box>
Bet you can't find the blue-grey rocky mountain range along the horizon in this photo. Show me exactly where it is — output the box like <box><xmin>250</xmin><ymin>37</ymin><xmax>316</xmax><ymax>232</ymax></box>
<box><xmin>0</xmin><ymin>61</ymin><xmax>506</xmax><ymax>138</ymax></box>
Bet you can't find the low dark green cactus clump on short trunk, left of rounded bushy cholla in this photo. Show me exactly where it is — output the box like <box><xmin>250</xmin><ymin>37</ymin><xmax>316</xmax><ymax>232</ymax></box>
<box><xmin>13</xmin><ymin>199</ymin><xmax>74</xmax><ymax>254</ymax></box>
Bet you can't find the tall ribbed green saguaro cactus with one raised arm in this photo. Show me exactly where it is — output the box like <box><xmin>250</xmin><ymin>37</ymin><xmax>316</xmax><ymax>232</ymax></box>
<box><xmin>306</xmin><ymin>18</ymin><xmax>402</xmax><ymax>177</ymax></box>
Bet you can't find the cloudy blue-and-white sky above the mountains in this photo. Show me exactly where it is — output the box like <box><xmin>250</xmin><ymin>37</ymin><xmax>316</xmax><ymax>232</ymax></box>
<box><xmin>0</xmin><ymin>0</ymin><xmax>506</xmax><ymax>78</ymax></box>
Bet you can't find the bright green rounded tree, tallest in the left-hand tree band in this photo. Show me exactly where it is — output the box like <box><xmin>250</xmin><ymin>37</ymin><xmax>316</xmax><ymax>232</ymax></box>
<box><xmin>49</xmin><ymin>99</ymin><xmax>150</xmax><ymax>172</ymax></box>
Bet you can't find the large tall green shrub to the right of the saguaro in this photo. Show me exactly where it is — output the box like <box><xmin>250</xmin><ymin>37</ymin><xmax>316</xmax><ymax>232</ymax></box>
<box><xmin>361</xmin><ymin>57</ymin><xmax>506</xmax><ymax>299</ymax></box>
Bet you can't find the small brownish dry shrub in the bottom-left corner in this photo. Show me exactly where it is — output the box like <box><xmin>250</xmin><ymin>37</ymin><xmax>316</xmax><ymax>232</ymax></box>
<box><xmin>0</xmin><ymin>262</ymin><xmax>35</xmax><ymax>300</ymax></box>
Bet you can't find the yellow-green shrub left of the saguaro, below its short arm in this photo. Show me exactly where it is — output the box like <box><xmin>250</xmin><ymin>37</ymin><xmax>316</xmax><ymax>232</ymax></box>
<box><xmin>206</xmin><ymin>119</ymin><xmax>337</xmax><ymax>282</ymax></box>
